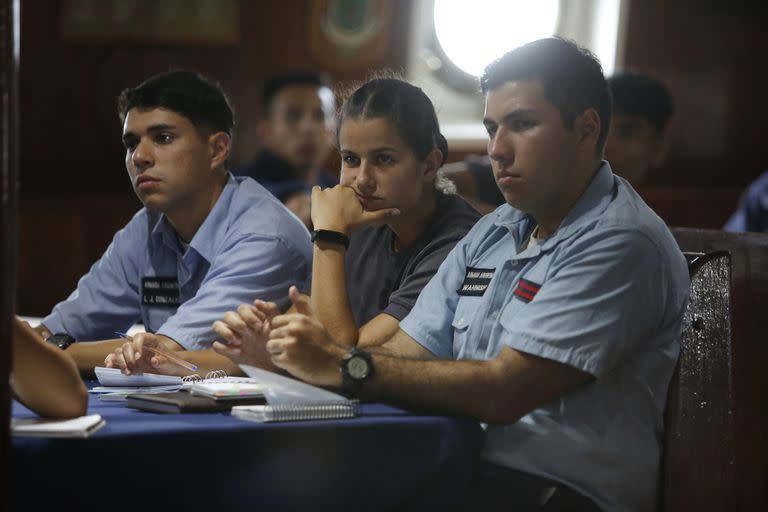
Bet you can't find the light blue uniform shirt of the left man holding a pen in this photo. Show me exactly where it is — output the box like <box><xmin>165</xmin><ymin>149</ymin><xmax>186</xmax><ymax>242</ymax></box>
<box><xmin>43</xmin><ymin>174</ymin><xmax>312</xmax><ymax>350</ymax></box>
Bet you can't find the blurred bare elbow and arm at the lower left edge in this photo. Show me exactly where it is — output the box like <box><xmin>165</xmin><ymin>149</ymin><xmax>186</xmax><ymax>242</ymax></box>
<box><xmin>11</xmin><ymin>318</ymin><xmax>88</xmax><ymax>418</ymax></box>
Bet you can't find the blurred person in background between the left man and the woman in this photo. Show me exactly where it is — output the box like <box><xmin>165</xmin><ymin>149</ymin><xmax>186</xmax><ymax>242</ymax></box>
<box><xmin>233</xmin><ymin>70</ymin><xmax>338</xmax><ymax>227</ymax></box>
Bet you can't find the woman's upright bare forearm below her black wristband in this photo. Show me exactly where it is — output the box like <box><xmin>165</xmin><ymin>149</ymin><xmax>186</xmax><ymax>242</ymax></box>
<box><xmin>310</xmin><ymin>241</ymin><xmax>359</xmax><ymax>345</ymax></box>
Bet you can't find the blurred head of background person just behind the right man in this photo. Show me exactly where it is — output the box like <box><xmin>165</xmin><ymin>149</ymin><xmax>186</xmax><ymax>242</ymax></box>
<box><xmin>605</xmin><ymin>72</ymin><xmax>673</xmax><ymax>187</ymax></box>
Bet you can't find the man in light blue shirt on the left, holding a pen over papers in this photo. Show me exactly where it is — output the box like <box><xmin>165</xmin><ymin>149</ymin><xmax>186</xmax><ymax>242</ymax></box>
<box><xmin>38</xmin><ymin>71</ymin><xmax>312</xmax><ymax>371</ymax></box>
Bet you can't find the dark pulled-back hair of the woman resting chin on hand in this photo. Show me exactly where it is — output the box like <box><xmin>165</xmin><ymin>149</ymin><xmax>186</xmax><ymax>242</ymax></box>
<box><xmin>336</xmin><ymin>78</ymin><xmax>448</xmax><ymax>165</ymax></box>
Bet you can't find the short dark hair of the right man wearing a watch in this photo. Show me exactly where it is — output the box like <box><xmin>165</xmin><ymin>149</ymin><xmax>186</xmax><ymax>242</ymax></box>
<box><xmin>480</xmin><ymin>37</ymin><xmax>611</xmax><ymax>154</ymax></box>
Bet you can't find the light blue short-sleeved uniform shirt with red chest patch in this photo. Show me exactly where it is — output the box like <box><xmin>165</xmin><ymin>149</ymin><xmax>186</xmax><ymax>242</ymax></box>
<box><xmin>400</xmin><ymin>163</ymin><xmax>689</xmax><ymax>511</ymax></box>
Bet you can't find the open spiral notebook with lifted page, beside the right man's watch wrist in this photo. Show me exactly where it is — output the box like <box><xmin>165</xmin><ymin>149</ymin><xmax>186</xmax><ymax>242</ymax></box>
<box><xmin>232</xmin><ymin>364</ymin><xmax>359</xmax><ymax>422</ymax></box>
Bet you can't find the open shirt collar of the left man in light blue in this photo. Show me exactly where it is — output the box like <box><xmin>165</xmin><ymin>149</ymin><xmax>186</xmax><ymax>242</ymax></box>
<box><xmin>152</xmin><ymin>173</ymin><xmax>238</xmax><ymax>263</ymax></box>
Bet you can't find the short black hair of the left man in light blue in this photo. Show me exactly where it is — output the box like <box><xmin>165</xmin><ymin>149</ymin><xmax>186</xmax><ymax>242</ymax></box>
<box><xmin>117</xmin><ymin>70</ymin><xmax>235</xmax><ymax>135</ymax></box>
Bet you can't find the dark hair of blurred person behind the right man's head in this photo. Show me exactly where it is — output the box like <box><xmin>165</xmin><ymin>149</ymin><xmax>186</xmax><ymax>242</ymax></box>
<box><xmin>608</xmin><ymin>71</ymin><xmax>674</xmax><ymax>134</ymax></box>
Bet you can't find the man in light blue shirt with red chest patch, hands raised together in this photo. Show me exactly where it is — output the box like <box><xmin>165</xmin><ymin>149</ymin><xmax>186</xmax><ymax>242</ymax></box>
<box><xmin>225</xmin><ymin>38</ymin><xmax>689</xmax><ymax>511</ymax></box>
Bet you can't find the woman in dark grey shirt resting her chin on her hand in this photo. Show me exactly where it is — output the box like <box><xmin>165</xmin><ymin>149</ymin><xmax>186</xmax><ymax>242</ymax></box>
<box><xmin>214</xmin><ymin>78</ymin><xmax>480</xmax><ymax>366</ymax></box>
